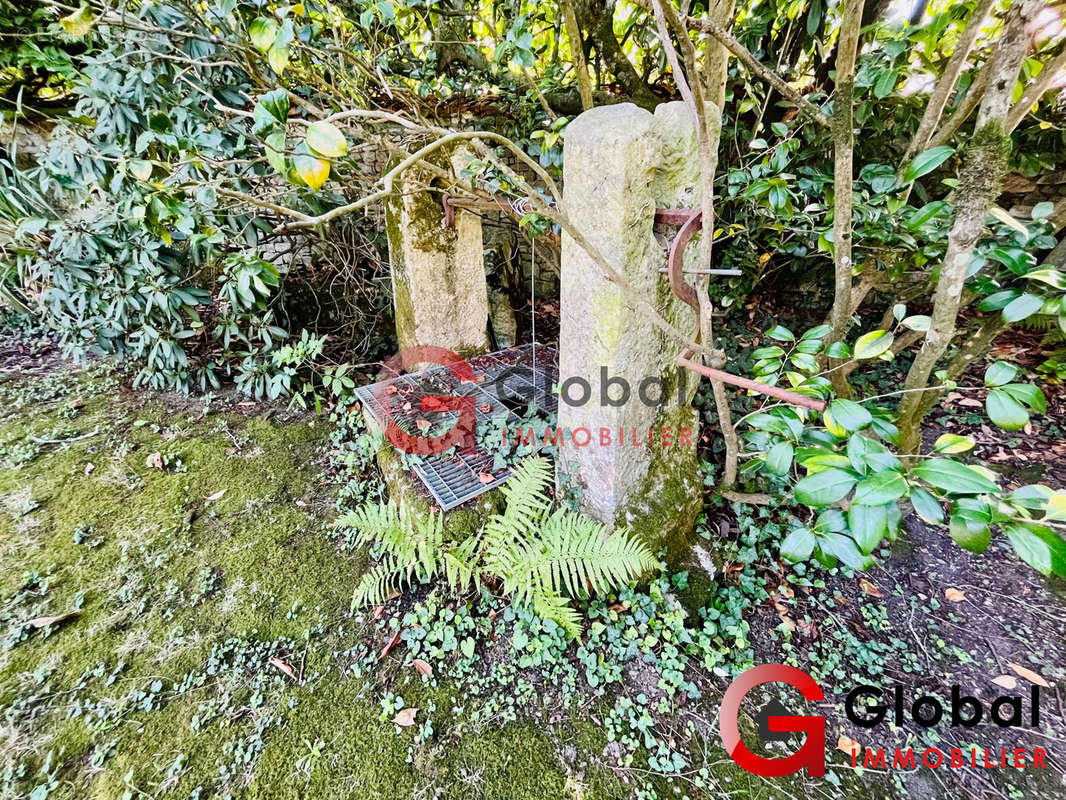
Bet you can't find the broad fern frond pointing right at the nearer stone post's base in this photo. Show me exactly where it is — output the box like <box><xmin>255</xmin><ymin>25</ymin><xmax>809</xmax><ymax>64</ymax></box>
<box><xmin>498</xmin><ymin>509</ymin><xmax>656</xmax><ymax>599</ymax></box>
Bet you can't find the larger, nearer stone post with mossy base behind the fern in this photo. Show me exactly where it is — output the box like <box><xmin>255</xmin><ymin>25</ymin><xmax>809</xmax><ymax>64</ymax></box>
<box><xmin>558</xmin><ymin>102</ymin><xmax>716</xmax><ymax>556</ymax></box>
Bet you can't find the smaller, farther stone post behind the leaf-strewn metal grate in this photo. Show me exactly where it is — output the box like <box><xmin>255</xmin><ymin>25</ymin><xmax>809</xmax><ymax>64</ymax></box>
<box><xmin>385</xmin><ymin>151</ymin><xmax>488</xmax><ymax>356</ymax></box>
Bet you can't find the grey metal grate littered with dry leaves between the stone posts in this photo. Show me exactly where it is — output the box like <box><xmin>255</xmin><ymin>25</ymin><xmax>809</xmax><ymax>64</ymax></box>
<box><xmin>355</xmin><ymin>345</ymin><xmax>559</xmax><ymax>511</ymax></box>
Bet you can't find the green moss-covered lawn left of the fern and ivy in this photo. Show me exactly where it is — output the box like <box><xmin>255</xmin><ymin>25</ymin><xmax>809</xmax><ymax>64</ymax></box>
<box><xmin>0</xmin><ymin>356</ymin><xmax>625</xmax><ymax>800</ymax></box>
